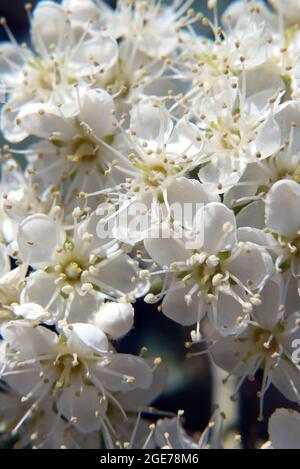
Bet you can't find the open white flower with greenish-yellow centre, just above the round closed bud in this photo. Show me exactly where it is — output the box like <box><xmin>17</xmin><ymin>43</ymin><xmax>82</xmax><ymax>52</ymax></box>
<box><xmin>18</xmin><ymin>214</ymin><xmax>147</xmax><ymax>322</ymax></box>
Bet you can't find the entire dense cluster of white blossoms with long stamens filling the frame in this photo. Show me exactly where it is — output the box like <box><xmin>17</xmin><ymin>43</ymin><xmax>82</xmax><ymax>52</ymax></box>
<box><xmin>0</xmin><ymin>0</ymin><xmax>300</xmax><ymax>448</ymax></box>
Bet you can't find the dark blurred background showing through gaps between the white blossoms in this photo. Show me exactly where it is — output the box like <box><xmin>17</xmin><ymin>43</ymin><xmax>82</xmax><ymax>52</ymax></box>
<box><xmin>0</xmin><ymin>0</ymin><xmax>291</xmax><ymax>448</ymax></box>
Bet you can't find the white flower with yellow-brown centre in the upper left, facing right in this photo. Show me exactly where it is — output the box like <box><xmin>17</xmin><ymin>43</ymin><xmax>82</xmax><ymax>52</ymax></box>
<box><xmin>14</xmin><ymin>88</ymin><xmax>129</xmax><ymax>210</ymax></box>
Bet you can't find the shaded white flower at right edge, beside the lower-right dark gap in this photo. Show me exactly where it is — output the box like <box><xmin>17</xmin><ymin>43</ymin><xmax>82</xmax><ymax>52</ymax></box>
<box><xmin>212</xmin><ymin>277</ymin><xmax>300</xmax><ymax>419</ymax></box>
